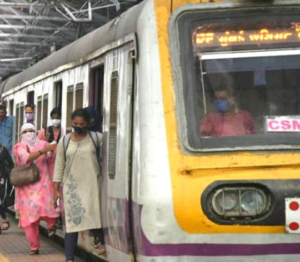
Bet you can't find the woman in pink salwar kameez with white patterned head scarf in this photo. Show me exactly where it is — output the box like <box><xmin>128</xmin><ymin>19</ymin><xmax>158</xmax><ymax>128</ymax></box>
<box><xmin>13</xmin><ymin>123</ymin><xmax>58</xmax><ymax>255</ymax></box>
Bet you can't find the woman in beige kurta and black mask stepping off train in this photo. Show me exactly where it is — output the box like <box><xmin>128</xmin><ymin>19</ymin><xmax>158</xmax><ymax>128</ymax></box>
<box><xmin>53</xmin><ymin>109</ymin><xmax>106</xmax><ymax>262</ymax></box>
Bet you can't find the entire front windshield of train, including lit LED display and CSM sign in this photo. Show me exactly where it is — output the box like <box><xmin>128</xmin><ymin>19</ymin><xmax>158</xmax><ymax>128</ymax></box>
<box><xmin>181</xmin><ymin>9</ymin><xmax>300</xmax><ymax>150</ymax></box>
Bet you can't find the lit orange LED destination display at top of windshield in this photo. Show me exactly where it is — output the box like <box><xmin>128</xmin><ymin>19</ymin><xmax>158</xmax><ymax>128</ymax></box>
<box><xmin>194</xmin><ymin>23</ymin><xmax>300</xmax><ymax>50</ymax></box>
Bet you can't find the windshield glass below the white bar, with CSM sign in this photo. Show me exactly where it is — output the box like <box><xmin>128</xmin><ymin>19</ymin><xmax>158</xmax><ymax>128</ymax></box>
<box><xmin>199</xmin><ymin>56</ymin><xmax>300</xmax><ymax>138</ymax></box>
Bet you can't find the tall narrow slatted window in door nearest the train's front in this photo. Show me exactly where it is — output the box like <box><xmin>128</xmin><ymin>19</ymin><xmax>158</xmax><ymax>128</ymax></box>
<box><xmin>108</xmin><ymin>72</ymin><xmax>119</xmax><ymax>179</ymax></box>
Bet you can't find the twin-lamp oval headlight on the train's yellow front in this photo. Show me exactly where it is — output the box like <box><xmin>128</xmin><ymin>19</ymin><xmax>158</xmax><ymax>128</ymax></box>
<box><xmin>210</xmin><ymin>187</ymin><xmax>270</xmax><ymax>218</ymax></box>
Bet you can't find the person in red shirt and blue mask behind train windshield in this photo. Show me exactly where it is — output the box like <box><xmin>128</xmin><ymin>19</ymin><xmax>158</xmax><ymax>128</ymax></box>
<box><xmin>200</xmin><ymin>88</ymin><xmax>256</xmax><ymax>137</ymax></box>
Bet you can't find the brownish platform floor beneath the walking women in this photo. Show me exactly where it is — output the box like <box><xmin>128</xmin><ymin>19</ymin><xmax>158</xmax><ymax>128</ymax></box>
<box><xmin>0</xmin><ymin>217</ymin><xmax>84</xmax><ymax>262</ymax></box>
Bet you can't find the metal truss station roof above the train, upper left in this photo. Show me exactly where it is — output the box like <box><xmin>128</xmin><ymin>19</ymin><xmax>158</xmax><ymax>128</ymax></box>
<box><xmin>0</xmin><ymin>0</ymin><xmax>141</xmax><ymax>81</ymax></box>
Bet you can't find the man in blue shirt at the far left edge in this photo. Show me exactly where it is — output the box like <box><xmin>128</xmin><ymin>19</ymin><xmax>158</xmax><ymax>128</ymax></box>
<box><xmin>0</xmin><ymin>105</ymin><xmax>14</xmax><ymax>155</ymax></box>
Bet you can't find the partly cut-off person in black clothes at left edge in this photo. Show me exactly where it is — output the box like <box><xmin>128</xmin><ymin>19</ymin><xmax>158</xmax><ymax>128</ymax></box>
<box><xmin>0</xmin><ymin>144</ymin><xmax>14</xmax><ymax>233</ymax></box>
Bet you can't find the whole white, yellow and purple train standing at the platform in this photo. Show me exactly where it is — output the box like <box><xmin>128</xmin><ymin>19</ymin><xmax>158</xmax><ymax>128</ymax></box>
<box><xmin>0</xmin><ymin>0</ymin><xmax>300</xmax><ymax>262</ymax></box>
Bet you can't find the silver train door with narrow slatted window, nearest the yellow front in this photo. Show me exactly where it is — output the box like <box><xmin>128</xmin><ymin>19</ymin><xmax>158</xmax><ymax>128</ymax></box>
<box><xmin>101</xmin><ymin>44</ymin><xmax>134</xmax><ymax>262</ymax></box>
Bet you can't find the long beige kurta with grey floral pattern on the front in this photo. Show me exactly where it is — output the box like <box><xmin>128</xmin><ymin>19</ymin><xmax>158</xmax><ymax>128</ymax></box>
<box><xmin>53</xmin><ymin>133</ymin><xmax>102</xmax><ymax>233</ymax></box>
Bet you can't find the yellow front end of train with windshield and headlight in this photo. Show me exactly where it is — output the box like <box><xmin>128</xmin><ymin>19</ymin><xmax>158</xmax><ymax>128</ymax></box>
<box><xmin>152</xmin><ymin>1</ymin><xmax>300</xmax><ymax>262</ymax></box>
